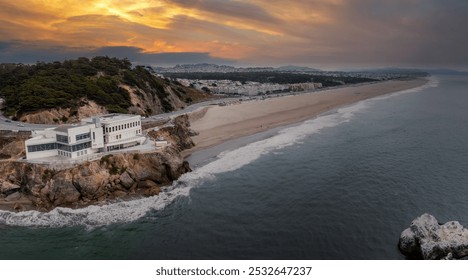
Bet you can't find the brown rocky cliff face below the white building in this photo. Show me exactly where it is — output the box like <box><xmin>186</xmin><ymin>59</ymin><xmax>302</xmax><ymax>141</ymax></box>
<box><xmin>0</xmin><ymin>116</ymin><xmax>191</xmax><ymax>211</ymax></box>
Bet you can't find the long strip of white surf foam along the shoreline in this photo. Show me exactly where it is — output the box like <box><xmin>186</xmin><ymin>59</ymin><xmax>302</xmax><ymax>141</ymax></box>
<box><xmin>0</xmin><ymin>78</ymin><xmax>438</xmax><ymax>228</ymax></box>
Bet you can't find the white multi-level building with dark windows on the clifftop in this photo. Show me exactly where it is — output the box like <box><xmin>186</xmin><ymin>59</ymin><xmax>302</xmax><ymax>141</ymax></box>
<box><xmin>25</xmin><ymin>114</ymin><xmax>146</xmax><ymax>159</ymax></box>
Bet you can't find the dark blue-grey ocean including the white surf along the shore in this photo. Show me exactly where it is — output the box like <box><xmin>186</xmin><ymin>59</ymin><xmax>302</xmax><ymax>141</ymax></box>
<box><xmin>0</xmin><ymin>76</ymin><xmax>468</xmax><ymax>260</ymax></box>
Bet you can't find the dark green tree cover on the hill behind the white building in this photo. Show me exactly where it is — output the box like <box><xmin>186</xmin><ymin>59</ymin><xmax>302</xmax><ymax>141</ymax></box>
<box><xmin>0</xmin><ymin>57</ymin><xmax>207</xmax><ymax>119</ymax></box>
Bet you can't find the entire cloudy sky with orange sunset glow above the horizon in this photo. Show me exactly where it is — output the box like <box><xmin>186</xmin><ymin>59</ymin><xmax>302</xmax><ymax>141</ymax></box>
<box><xmin>0</xmin><ymin>0</ymin><xmax>468</xmax><ymax>69</ymax></box>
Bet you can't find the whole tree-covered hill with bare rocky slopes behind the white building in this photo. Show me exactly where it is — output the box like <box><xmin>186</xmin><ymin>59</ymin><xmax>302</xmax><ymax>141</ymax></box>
<box><xmin>0</xmin><ymin>56</ymin><xmax>209</xmax><ymax>123</ymax></box>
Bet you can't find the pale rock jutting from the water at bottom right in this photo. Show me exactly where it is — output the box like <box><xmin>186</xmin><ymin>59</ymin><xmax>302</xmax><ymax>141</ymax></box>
<box><xmin>398</xmin><ymin>213</ymin><xmax>468</xmax><ymax>260</ymax></box>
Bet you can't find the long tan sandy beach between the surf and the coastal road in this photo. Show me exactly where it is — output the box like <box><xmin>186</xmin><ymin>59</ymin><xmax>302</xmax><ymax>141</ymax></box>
<box><xmin>184</xmin><ymin>79</ymin><xmax>427</xmax><ymax>156</ymax></box>
